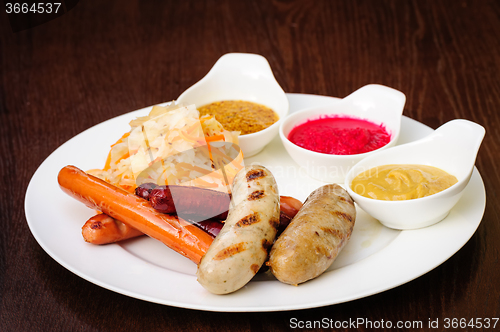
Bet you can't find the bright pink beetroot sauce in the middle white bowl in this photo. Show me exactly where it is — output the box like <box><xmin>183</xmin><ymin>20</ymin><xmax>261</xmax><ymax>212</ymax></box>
<box><xmin>288</xmin><ymin>116</ymin><xmax>391</xmax><ymax>155</ymax></box>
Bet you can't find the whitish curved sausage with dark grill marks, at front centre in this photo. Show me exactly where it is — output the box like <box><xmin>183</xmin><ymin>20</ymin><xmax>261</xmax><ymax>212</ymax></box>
<box><xmin>197</xmin><ymin>166</ymin><xmax>280</xmax><ymax>294</ymax></box>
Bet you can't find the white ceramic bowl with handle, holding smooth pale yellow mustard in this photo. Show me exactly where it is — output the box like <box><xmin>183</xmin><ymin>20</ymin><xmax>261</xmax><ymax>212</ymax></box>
<box><xmin>345</xmin><ymin>120</ymin><xmax>485</xmax><ymax>229</ymax></box>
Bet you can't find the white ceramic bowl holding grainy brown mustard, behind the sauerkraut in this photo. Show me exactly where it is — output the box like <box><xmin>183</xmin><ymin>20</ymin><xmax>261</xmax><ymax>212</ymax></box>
<box><xmin>176</xmin><ymin>53</ymin><xmax>289</xmax><ymax>157</ymax></box>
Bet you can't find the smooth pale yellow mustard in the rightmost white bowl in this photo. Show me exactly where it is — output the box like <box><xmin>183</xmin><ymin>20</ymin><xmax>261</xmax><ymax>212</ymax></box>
<box><xmin>351</xmin><ymin>165</ymin><xmax>458</xmax><ymax>201</ymax></box>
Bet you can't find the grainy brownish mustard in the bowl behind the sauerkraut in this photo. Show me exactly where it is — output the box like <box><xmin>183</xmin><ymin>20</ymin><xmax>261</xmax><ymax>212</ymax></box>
<box><xmin>198</xmin><ymin>100</ymin><xmax>279</xmax><ymax>135</ymax></box>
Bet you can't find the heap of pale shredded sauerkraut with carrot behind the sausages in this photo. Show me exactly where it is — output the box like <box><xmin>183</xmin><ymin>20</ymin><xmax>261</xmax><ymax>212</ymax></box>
<box><xmin>88</xmin><ymin>103</ymin><xmax>244</xmax><ymax>192</ymax></box>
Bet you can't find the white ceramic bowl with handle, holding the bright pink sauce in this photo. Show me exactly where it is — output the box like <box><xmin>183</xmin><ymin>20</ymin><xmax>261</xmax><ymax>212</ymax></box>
<box><xmin>280</xmin><ymin>84</ymin><xmax>406</xmax><ymax>183</ymax></box>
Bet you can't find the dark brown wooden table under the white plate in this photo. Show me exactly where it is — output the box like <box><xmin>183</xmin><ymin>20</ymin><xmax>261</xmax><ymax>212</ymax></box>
<box><xmin>0</xmin><ymin>0</ymin><xmax>500</xmax><ymax>331</ymax></box>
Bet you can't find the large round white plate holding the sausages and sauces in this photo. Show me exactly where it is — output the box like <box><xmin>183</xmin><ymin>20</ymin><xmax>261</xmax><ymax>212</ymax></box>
<box><xmin>25</xmin><ymin>94</ymin><xmax>486</xmax><ymax>312</ymax></box>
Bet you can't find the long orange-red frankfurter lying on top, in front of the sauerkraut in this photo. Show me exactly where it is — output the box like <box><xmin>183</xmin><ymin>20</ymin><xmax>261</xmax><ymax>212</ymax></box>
<box><xmin>58</xmin><ymin>166</ymin><xmax>213</xmax><ymax>264</ymax></box>
